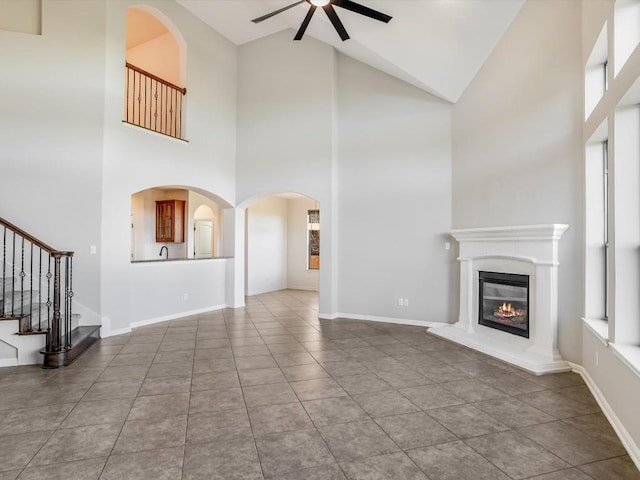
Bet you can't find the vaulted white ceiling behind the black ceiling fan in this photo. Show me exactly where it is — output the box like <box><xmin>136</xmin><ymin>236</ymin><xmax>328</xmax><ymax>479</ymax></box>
<box><xmin>177</xmin><ymin>0</ymin><xmax>525</xmax><ymax>102</ymax></box>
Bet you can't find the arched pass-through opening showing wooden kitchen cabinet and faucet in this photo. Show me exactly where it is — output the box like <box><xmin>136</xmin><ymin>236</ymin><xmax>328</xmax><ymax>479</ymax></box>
<box><xmin>131</xmin><ymin>186</ymin><xmax>230</xmax><ymax>262</ymax></box>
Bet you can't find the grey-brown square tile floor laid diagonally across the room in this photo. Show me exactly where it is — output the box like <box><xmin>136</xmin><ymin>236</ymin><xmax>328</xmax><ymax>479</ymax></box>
<box><xmin>0</xmin><ymin>290</ymin><xmax>640</xmax><ymax>480</ymax></box>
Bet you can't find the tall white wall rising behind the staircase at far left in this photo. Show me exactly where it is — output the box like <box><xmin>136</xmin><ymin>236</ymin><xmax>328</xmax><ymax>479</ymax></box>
<box><xmin>0</xmin><ymin>0</ymin><xmax>106</xmax><ymax>321</ymax></box>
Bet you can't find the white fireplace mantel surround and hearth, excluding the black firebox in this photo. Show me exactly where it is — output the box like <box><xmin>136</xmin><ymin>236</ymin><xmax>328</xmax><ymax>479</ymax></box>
<box><xmin>429</xmin><ymin>224</ymin><xmax>571</xmax><ymax>375</ymax></box>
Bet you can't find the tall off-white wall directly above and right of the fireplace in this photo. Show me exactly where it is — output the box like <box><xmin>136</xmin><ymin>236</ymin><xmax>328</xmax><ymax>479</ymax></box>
<box><xmin>452</xmin><ymin>0</ymin><xmax>584</xmax><ymax>362</ymax></box>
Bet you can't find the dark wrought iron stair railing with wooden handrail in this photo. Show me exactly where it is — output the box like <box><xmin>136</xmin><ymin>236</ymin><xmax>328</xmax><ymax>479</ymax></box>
<box><xmin>0</xmin><ymin>217</ymin><xmax>73</xmax><ymax>364</ymax></box>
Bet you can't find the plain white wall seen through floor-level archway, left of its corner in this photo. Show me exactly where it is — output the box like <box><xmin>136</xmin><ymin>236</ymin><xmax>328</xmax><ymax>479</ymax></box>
<box><xmin>246</xmin><ymin>196</ymin><xmax>287</xmax><ymax>295</ymax></box>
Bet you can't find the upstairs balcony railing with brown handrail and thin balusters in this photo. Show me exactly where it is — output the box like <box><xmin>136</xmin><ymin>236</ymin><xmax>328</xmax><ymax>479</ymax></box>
<box><xmin>124</xmin><ymin>63</ymin><xmax>187</xmax><ymax>140</ymax></box>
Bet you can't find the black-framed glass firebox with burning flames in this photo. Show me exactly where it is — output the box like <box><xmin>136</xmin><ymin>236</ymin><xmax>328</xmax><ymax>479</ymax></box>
<box><xmin>478</xmin><ymin>271</ymin><xmax>529</xmax><ymax>338</ymax></box>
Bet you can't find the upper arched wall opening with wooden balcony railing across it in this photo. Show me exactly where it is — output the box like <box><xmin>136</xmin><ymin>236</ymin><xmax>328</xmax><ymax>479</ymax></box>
<box><xmin>124</xmin><ymin>7</ymin><xmax>187</xmax><ymax>139</ymax></box>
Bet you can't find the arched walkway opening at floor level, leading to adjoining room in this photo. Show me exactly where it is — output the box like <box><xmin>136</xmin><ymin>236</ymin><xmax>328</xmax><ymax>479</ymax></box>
<box><xmin>245</xmin><ymin>193</ymin><xmax>320</xmax><ymax>296</ymax></box>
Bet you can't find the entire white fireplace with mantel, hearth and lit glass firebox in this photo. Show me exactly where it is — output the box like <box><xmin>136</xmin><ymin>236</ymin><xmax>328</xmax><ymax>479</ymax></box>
<box><xmin>429</xmin><ymin>224</ymin><xmax>571</xmax><ymax>375</ymax></box>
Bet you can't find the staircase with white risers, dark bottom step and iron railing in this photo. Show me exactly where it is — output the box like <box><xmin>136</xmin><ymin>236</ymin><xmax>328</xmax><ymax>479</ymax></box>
<box><xmin>0</xmin><ymin>217</ymin><xmax>100</xmax><ymax>368</ymax></box>
